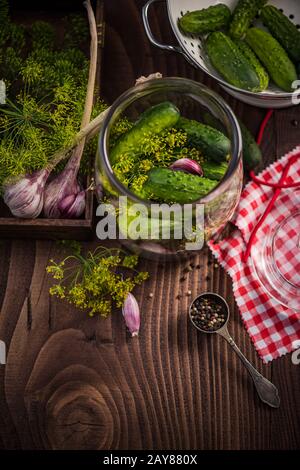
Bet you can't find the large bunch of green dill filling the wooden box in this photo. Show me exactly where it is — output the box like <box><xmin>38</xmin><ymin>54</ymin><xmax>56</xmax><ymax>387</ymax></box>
<box><xmin>0</xmin><ymin>0</ymin><xmax>107</xmax><ymax>186</ymax></box>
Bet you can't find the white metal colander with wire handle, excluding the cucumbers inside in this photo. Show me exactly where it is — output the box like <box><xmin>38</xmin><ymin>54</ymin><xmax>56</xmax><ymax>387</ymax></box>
<box><xmin>143</xmin><ymin>0</ymin><xmax>300</xmax><ymax>108</ymax></box>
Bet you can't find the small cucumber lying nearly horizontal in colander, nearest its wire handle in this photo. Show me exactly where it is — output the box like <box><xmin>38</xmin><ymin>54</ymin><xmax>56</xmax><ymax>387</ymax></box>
<box><xmin>178</xmin><ymin>4</ymin><xmax>231</xmax><ymax>34</ymax></box>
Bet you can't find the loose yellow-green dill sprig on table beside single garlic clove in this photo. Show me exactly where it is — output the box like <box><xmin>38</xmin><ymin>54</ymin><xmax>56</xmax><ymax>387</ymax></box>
<box><xmin>46</xmin><ymin>245</ymin><xmax>148</xmax><ymax>317</ymax></box>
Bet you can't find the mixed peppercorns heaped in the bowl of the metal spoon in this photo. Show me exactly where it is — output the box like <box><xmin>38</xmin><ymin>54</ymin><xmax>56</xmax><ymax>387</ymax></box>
<box><xmin>190</xmin><ymin>296</ymin><xmax>227</xmax><ymax>331</ymax></box>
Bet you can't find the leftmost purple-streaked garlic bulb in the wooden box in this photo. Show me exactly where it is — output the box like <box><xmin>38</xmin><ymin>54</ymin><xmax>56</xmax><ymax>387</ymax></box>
<box><xmin>3</xmin><ymin>170</ymin><xmax>49</xmax><ymax>219</ymax></box>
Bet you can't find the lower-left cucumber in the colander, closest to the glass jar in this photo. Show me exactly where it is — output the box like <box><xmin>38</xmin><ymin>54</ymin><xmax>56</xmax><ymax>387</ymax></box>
<box><xmin>206</xmin><ymin>32</ymin><xmax>261</xmax><ymax>91</ymax></box>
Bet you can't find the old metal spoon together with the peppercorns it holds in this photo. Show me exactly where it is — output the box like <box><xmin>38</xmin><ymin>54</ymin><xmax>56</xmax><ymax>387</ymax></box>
<box><xmin>189</xmin><ymin>292</ymin><xmax>280</xmax><ymax>408</ymax></box>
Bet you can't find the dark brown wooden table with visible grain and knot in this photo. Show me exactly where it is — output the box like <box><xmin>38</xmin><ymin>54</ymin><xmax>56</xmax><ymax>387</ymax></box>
<box><xmin>0</xmin><ymin>0</ymin><xmax>300</xmax><ymax>449</ymax></box>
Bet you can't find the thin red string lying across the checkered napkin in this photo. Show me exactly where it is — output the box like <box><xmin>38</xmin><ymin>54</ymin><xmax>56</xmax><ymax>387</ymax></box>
<box><xmin>242</xmin><ymin>109</ymin><xmax>300</xmax><ymax>262</ymax></box>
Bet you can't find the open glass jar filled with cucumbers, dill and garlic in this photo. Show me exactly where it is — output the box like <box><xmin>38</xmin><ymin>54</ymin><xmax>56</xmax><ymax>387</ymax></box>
<box><xmin>96</xmin><ymin>78</ymin><xmax>243</xmax><ymax>258</ymax></box>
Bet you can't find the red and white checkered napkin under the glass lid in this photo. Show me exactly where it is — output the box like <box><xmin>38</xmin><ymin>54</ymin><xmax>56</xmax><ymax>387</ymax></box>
<box><xmin>209</xmin><ymin>147</ymin><xmax>300</xmax><ymax>363</ymax></box>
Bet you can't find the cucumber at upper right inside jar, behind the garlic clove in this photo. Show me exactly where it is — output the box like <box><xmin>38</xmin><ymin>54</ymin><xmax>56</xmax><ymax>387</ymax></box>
<box><xmin>177</xmin><ymin>118</ymin><xmax>231</xmax><ymax>162</ymax></box>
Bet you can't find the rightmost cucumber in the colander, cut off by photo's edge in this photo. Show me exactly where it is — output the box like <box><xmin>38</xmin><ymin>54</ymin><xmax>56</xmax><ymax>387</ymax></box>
<box><xmin>261</xmin><ymin>5</ymin><xmax>300</xmax><ymax>63</ymax></box>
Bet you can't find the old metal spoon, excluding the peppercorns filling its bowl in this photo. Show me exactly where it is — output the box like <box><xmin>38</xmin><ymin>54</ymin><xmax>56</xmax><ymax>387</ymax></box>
<box><xmin>189</xmin><ymin>292</ymin><xmax>280</xmax><ymax>408</ymax></box>
